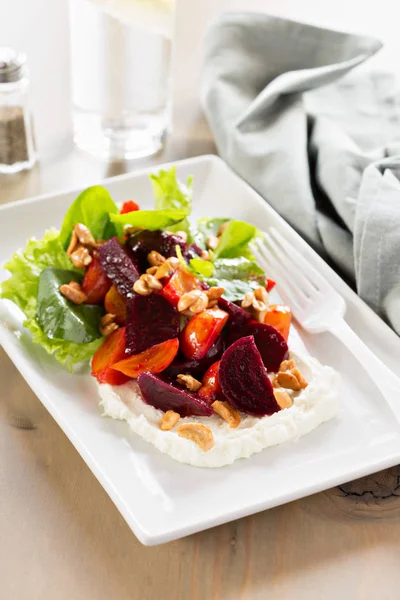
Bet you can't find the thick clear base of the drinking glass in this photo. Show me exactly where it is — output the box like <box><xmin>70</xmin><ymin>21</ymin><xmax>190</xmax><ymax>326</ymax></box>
<box><xmin>73</xmin><ymin>108</ymin><xmax>168</xmax><ymax>160</ymax></box>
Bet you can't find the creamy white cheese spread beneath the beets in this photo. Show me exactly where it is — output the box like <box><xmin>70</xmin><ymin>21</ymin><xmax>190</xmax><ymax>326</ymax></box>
<box><xmin>99</xmin><ymin>352</ymin><xmax>339</xmax><ymax>467</ymax></box>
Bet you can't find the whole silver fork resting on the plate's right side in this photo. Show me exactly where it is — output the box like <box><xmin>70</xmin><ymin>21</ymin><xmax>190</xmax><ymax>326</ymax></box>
<box><xmin>253</xmin><ymin>228</ymin><xmax>400</xmax><ymax>422</ymax></box>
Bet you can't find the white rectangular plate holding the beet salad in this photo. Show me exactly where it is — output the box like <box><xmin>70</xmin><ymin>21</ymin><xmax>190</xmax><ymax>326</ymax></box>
<box><xmin>0</xmin><ymin>156</ymin><xmax>400</xmax><ymax>545</ymax></box>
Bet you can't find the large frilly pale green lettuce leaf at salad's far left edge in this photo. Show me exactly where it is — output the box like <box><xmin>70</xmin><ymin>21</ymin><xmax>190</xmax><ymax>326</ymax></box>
<box><xmin>0</xmin><ymin>229</ymin><xmax>103</xmax><ymax>370</ymax></box>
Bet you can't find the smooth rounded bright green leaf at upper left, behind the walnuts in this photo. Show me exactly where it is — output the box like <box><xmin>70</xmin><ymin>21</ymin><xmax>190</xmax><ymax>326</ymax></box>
<box><xmin>60</xmin><ymin>185</ymin><xmax>122</xmax><ymax>248</ymax></box>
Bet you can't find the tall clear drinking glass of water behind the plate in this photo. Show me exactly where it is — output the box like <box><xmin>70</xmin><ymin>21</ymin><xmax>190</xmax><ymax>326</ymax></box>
<box><xmin>69</xmin><ymin>0</ymin><xmax>175</xmax><ymax>160</ymax></box>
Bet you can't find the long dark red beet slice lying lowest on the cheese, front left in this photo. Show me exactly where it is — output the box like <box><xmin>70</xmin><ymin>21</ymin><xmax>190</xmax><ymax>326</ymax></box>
<box><xmin>137</xmin><ymin>372</ymin><xmax>213</xmax><ymax>417</ymax></box>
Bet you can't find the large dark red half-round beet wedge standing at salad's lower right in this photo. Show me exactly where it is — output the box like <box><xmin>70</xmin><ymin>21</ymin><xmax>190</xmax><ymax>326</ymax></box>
<box><xmin>218</xmin><ymin>335</ymin><xmax>280</xmax><ymax>416</ymax></box>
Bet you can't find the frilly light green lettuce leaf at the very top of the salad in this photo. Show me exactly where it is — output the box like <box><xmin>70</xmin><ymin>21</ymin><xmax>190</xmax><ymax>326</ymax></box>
<box><xmin>150</xmin><ymin>167</ymin><xmax>193</xmax><ymax>241</ymax></box>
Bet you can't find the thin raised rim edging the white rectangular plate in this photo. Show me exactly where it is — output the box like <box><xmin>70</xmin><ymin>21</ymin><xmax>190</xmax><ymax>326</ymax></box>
<box><xmin>0</xmin><ymin>154</ymin><xmax>400</xmax><ymax>546</ymax></box>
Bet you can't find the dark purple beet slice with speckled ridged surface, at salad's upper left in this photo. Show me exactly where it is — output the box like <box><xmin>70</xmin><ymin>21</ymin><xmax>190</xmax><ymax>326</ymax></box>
<box><xmin>99</xmin><ymin>238</ymin><xmax>140</xmax><ymax>298</ymax></box>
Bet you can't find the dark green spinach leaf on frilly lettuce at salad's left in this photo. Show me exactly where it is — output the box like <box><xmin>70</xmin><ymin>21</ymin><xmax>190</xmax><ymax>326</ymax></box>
<box><xmin>36</xmin><ymin>267</ymin><xmax>104</xmax><ymax>344</ymax></box>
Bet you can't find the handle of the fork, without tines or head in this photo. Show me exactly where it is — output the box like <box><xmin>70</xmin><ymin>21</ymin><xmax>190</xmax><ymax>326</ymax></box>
<box><xmin>329</xmin><ymin>318</ymin><xmax>400</xmax><ymax>410</ymax></box>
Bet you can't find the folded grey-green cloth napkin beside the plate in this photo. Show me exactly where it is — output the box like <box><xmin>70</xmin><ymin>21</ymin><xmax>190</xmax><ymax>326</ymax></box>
<box><xmin>202</xmin><ymin>13</ymin><xmax>400</xmax><ymax>334</ymax></box>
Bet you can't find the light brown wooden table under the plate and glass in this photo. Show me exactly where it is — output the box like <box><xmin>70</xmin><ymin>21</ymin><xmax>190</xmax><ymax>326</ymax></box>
<box><xmin>0</xmin><ymin>0</ymin><xmax>400</xmax><ymax>600</ymax></box>
